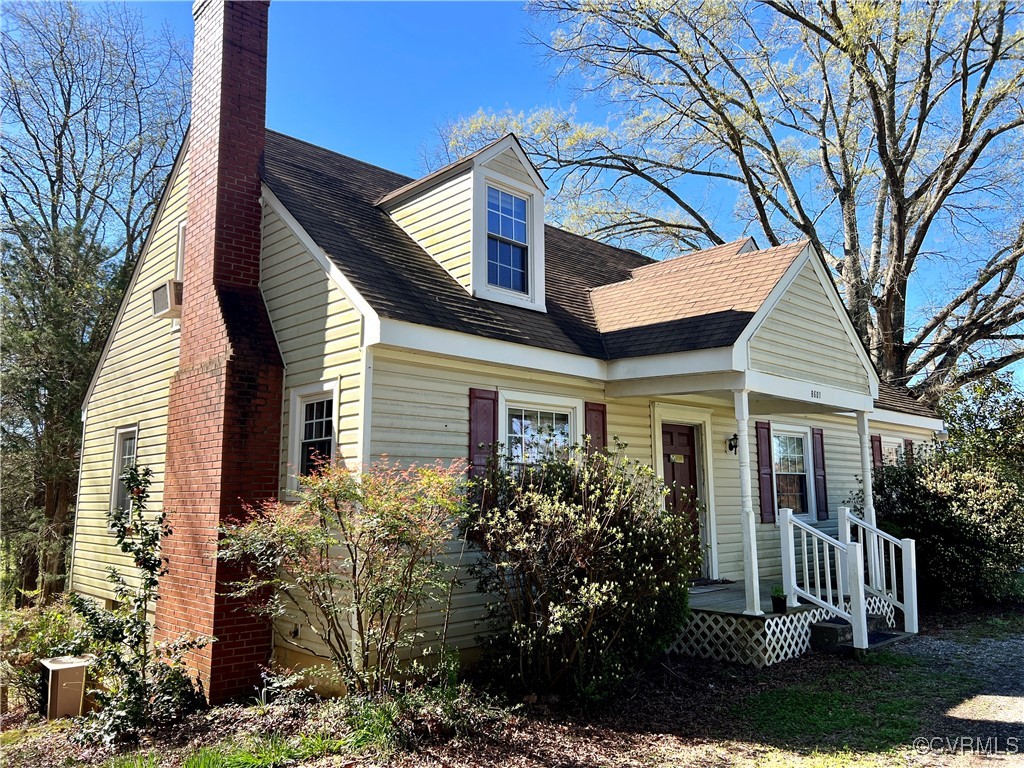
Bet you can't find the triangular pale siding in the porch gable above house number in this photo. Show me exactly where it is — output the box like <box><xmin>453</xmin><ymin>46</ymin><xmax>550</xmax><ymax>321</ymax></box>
<box><xmin>749</xmin><ymin>264</ymin><xmax>869</xmax><ymax>394</ymax></box>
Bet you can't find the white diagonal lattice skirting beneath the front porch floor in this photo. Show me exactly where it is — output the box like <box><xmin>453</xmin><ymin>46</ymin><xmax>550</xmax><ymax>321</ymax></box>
<box><xmin>672</xmin><ymin>595</ymin><xmax>895</xmax><ymax>667</ymax></box>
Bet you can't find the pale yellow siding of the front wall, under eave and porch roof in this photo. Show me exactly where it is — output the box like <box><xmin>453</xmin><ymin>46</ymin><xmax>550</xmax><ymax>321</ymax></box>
<box><xmin>371</xmin><ymin>350</ymin><xmax>930</xmax><ymax>634</ymax></box>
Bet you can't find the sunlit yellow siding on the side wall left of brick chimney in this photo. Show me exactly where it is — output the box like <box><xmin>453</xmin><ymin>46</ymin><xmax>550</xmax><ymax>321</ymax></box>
<box><xmin>72</xmin><ymin>160</ymin><xmax>188</xmax><ymax>599</ymax></box>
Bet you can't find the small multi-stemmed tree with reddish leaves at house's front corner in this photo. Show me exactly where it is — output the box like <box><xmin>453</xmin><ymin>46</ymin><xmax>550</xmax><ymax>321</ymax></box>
<box><xmin>220</xmin><ymin>461</ymin><xmax>464</xmax><ymax>693</ymax></box>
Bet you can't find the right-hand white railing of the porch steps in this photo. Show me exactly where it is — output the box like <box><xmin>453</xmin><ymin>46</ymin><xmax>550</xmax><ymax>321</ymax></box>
<box><xmin>839</xmin><ymin>507</ymin><xmax>918</xmax><ymax>634</ymax></box>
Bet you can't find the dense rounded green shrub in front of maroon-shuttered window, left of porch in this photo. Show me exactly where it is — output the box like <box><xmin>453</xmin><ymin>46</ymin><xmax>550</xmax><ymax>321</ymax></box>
<box><xmin>468</xmin><ymin>446</ymin><xmax>698</xmax><ymax>698</ymax></box>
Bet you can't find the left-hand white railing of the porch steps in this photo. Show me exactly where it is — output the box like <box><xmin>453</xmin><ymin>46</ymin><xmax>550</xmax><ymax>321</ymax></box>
<box><xmin>779</xmin><ymin>509</ymin><xmax>867</xmax><ymax>648</ymax></box>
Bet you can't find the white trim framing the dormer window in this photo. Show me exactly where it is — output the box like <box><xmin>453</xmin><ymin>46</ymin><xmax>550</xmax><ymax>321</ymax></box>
<box><xmin>470</xmin><ymin>165</ymin><xmax>547</xmax><ymax>312</ymax></box>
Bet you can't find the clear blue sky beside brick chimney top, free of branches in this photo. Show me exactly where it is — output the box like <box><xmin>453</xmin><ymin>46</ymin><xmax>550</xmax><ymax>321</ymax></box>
<box><xmin>141</xmin><ymin>0</ymin><xmax>587</xmax><ymax>176</ymax></box>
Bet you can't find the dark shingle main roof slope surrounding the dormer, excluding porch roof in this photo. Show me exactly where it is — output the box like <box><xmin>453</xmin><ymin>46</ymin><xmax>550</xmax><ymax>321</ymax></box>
<box><xmin>263</xmin><ymin>131</ymin><xmax>652</xmax><ymax>359</ymax></box>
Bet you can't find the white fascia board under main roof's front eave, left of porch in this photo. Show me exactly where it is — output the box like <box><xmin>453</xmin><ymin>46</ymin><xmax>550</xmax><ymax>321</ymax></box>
<box><xmin>377</xmin><ymin>317</ymin><xmax>607</xmax><ymax>381</ymax></box>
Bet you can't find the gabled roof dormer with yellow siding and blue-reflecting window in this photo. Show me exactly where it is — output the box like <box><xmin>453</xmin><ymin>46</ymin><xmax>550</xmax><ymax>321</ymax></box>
<box><xmin>378</xmin><ymin>133</ymin><xmax>547</xmax><ymax>312</ymax></box>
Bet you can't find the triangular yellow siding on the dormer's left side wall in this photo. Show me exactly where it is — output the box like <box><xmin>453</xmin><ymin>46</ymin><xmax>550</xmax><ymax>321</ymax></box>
<box><xmin>391</xmin><ymin>171</ymin><xmax>473</xmax><ymax>291</ymax></box>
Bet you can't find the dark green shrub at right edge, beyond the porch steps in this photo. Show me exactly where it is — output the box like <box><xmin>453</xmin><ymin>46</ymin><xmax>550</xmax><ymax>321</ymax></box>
<box><xmin>873</xmin><ymin>451</ymin><xmax>1024</xmax><ymax>609</ymax></box>
